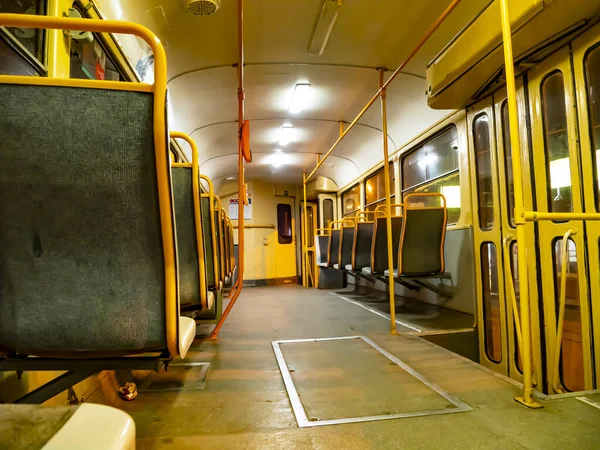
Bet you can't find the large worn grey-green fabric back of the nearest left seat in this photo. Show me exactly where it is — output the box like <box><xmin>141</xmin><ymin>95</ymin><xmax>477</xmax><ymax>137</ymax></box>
<box><xmin>0</xmin><ymin>84</ymin><xmax>166</xmax><ymax>356</ymax></box>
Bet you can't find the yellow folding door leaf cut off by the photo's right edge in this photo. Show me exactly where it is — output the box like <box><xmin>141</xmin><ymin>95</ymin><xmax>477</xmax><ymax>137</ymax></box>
<box><xmin>572</xmin><ymin>25</ymin><xmax>600</xmax><ymax>387</ymax></box>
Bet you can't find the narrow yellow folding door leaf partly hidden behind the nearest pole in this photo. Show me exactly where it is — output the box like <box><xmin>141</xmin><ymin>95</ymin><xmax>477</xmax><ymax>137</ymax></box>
<box><xmin>494</xmin><ymin>86</ymin><xmax>542</xmax><ymax>385</ymax></box>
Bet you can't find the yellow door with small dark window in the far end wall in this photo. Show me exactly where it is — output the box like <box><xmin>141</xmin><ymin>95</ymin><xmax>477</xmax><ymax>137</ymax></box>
<box><xmin>275</xmin><ymin>197</ymin><xmax>297</xmax><ymax>279</ymax></box>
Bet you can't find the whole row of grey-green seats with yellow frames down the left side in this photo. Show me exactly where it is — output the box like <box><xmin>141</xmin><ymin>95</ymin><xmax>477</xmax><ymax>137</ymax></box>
<box><xmin>0</xmin><ymin>14</ymin><xmax>235</xmax><ymax>403</ymax></box>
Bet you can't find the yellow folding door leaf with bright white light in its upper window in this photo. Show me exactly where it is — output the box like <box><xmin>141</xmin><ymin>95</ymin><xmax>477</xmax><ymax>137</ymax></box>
<box><xmin>529</xmin><ymin>47</ymin><xmax>598</xmax><ymax>393</ymax></box>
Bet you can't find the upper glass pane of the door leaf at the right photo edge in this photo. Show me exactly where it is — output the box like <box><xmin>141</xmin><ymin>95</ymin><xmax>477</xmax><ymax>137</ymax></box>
<box><xmin>585</xmin><ymin>46</ymin><xmax>600</xmax><ymax>211</ymax></box>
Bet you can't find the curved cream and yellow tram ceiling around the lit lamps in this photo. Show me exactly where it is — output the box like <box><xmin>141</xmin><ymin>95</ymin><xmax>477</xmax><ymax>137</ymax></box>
<box><xmin>97</xmin><ymin>0</ymin><xmax>489</xmax><ymax>186</ymax></box>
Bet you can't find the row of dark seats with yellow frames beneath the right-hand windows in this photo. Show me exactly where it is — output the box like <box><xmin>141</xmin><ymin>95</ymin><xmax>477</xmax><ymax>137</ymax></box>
<box><xmin>316</xmin><ymin>193</ymin><xmax>447</xmax><ymax>289</ymax></box>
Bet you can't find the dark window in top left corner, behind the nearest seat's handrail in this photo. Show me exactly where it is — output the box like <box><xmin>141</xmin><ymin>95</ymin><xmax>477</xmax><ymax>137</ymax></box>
<box><xmin>0</xmin><ymin>0</ymin><xmax>46</xmax><ymax>63</ymax></box>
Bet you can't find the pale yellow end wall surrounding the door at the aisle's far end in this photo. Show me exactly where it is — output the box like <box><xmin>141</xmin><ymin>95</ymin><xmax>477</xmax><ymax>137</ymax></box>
<box><xmin>217</xmin><ymin>180</ymin><xmax>300</xmax><ymax>280</ymax></box>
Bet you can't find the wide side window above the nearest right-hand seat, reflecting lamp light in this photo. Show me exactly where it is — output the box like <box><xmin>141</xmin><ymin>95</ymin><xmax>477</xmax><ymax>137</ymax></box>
<box><xmin>402</xmin><ymin>125</ymin><xmax>461</xmax><ymax>225</ymax></box>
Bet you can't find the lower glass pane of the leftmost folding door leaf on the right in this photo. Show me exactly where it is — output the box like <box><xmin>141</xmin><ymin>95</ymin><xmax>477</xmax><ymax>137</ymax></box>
<box><xmin>481</xmin><ymin>242</ymin><xmax>502</xmax><ymax>363</ymax></box>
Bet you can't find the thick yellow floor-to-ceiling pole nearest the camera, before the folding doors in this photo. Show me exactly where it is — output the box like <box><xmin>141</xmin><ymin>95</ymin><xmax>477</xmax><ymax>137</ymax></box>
<box><xmin>500</xmin><ymin>0</ymin><xmax>542</xmax><ymax>409</ymax></box>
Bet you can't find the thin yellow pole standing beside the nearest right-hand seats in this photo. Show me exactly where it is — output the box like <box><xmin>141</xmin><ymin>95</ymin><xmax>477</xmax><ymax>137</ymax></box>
<box><xmin>380</xmin><ymin>70</ymin><xmax>396</xmax><ymax>334</ymax></box>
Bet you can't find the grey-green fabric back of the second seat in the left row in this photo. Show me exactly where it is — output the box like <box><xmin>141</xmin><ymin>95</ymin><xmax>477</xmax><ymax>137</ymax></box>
<box><xmin>171</xmin><ymin>167</ymin><xmax>204</xmax><ymax>309</ymax></box>
